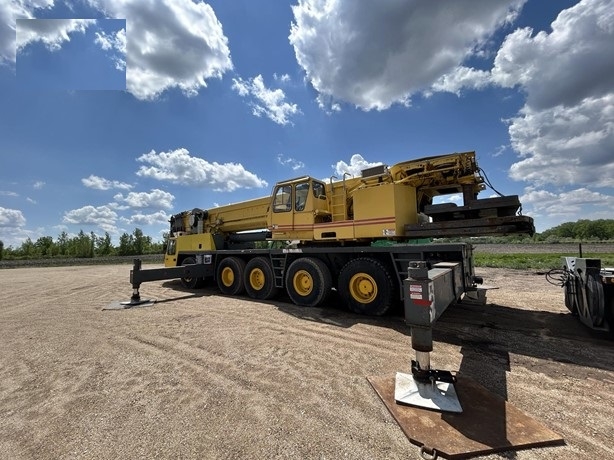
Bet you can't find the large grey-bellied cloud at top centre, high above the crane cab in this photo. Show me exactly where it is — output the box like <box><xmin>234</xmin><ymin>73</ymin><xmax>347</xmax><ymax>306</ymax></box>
<box><xmin>290</xmin><ymin>0</ymin><xmax>525</xmax><ymax>110</ymax></box>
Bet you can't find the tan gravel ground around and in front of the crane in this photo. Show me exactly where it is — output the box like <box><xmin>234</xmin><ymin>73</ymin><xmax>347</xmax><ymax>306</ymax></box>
<box><xmin>0</xmin><ymin>265</ymin><xmax>614</xmax><ymax>460</ymax></box>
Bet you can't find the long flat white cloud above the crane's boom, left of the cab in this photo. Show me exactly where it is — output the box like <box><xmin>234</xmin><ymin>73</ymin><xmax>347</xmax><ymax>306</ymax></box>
<box><xmin>137</xmin><ymin>148</ymin><xmax>268</xmax><ymax>192</ymax></box>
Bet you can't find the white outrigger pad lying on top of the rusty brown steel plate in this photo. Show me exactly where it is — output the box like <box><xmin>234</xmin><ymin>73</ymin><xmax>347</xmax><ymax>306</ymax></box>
<box><xmin>394</xmin><ymin>372</ymin><xmax>463</xmax><ymax>413</ymax></box>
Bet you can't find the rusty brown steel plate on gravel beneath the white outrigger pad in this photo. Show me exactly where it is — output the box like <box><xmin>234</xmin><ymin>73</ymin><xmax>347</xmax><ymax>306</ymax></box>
<box><xmin>367</xmin><ymin>375</ymin><xmax>565</xmax><ymax>459</ymax></box>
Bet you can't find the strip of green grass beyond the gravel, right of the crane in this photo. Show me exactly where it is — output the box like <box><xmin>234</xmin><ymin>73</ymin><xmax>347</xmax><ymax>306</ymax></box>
<box><xmin>473</xmin><ymin>253</ymin><xmax>614</xmax><ymax>270</ymax></box>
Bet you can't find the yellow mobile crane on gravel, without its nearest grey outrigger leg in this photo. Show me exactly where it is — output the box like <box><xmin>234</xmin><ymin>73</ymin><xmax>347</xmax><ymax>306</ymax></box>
<box><xmin>131</xmin><ymin>152</ymin><xmax>534</xmax><ymax>315</ymax></box>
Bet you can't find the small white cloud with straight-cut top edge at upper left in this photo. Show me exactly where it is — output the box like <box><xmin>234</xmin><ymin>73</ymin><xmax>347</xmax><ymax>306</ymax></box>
<box><xmin>16</xmin><ymin>19</ymin><xmax>96</xmax><ymax>52</ymax></box>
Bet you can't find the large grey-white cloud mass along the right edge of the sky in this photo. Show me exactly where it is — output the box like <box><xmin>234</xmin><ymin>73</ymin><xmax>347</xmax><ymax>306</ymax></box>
<box><xmin>431</xmin><ymin>0</ymin><xmax>614</xmax><ymax>187</ymax></box>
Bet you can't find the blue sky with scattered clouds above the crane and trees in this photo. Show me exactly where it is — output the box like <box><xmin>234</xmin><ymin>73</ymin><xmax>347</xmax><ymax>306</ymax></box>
<box><xmin>0</xmin><ymin>0</ymin><xmax>614</xmax><ymax>247</ymax></box>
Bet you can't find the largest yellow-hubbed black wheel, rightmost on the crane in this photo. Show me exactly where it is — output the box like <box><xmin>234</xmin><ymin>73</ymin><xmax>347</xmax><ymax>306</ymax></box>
<box><xmin>339</xmin><ymin>258</ymin><xmax>395</xmax><ymax>316</ymax></box>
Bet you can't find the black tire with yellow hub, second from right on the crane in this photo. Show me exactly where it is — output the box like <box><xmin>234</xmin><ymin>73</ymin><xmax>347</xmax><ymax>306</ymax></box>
<box><xmin>286</xmin><ymin>257</ymin><xmax>333</xmax><ymax>307</ymax></box>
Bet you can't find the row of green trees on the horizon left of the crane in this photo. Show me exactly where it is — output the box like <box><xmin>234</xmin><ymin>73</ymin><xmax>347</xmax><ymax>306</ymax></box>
<box><xmin>0</xmin><ymin>228</ymin><xmax>164</xmax><ymax>260</ymax></box>
